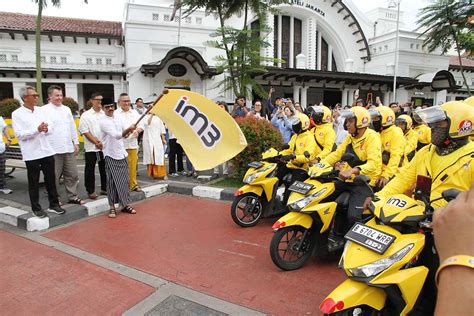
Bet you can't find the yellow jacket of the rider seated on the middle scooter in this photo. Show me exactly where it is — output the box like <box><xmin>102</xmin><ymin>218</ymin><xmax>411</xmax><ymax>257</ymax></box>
<box><xmin>322</xmin><ymin>128</ymin><xmax>382</xmax><ymax>186</ymax></box>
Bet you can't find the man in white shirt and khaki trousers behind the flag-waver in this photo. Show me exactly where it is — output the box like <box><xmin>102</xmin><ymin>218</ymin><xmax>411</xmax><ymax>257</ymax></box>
<box><xmin>115</xmin><ymin>93</ymin><xmax>143</xmax><ymax>192</ymax></box>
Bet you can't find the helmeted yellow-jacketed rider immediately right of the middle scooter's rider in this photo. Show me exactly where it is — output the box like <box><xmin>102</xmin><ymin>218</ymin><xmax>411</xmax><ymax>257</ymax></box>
<box><xmin>370</xmin><ymin>106</ymin><xmax>406</xmax><ymax>188</ymax></box>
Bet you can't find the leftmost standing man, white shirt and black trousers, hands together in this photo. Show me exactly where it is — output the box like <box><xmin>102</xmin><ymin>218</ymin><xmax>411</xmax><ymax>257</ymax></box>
<box><xmin>12</xmin><ymin>86</ymin><xmax>66</xmax><ymax>217</ymax></box>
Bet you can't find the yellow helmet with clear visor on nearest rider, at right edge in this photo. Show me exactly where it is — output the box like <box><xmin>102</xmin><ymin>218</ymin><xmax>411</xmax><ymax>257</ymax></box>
<box><xmin>416</xmin><ymin>101</ymin><xmax>474</xmax><ymax>139</ymax></box>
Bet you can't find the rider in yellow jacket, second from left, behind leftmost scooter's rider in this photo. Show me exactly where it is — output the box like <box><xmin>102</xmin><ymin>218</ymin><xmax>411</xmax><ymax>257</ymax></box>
<box><xmin>311</xmin><ymin>105</ymin><xmax>336</xmax><ymax>162</ymax></box>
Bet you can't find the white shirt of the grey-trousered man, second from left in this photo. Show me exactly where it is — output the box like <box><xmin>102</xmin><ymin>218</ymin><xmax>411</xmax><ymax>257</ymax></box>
<box><xmin>43</xmin><ymin>103</ymin><xmax>79</xmax><ymax>154</ymax></box>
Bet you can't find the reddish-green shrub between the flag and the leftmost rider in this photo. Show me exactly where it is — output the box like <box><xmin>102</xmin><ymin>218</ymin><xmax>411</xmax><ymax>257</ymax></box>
<box><xmin>232</xmin><ymin>117</ymin><xmax>283</xmax><ymax>179</ymax></box>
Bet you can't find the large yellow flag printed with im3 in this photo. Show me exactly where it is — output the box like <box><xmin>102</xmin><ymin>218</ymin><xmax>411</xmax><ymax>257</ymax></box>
<box><xmin>151</xmin><ymin>89</ymin><xmax>247</xmax><ymax>170</ymax></box>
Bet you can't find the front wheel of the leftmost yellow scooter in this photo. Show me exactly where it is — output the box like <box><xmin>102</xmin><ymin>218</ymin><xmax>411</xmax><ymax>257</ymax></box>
<box><xmin>230</xmin><ymin>193</ymin><xmax>263</xmax><ymax>227</ymax></box>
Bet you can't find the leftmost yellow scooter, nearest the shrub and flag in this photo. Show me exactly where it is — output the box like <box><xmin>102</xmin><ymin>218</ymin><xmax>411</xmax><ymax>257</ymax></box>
<box><xmin>230</xmin><ymin>147</ymin><xmax>300</xmax><ymax>227</ymax></box>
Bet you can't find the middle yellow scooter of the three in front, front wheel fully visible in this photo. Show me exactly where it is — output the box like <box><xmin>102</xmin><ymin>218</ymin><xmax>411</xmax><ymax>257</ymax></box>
<box><xmin>270</xmin><ymin>154</ymin><xmax>368</xmax><ymax>271</ymax></box>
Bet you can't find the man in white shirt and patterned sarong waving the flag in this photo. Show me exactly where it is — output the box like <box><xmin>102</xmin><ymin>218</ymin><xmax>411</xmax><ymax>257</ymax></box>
<box><xmin>100</xmin><ymin>99</ymin><xmax>136</xmax><ymax>218</ymax></box>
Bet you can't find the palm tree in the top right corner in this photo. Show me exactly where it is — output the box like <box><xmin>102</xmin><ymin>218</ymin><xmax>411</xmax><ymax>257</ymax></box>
<box><xmin>417</xmin><ymin>0</ymin><xmax>474</xmax><ymax>95</ymax></box>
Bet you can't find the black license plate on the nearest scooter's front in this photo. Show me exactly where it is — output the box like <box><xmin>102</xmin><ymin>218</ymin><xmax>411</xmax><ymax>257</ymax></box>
<box><xmin>345</xmin><ymin>223</ymin><xmax>395</xmax><ymax>254</ymax></box>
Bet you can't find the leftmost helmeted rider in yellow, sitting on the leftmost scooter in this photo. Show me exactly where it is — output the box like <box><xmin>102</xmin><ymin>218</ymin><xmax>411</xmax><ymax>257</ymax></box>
<box><xmin>277</xmin><ymin>113</ymin><xmax>316</xmax><ymax>205</ymax></box>
